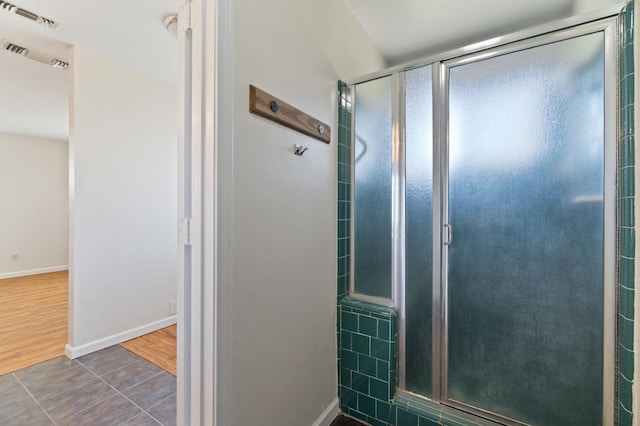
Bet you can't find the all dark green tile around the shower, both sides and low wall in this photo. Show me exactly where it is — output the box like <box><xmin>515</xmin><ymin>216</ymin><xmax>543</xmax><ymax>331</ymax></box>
<box><xmin>337</xmin><ymin>3</ymin><xmax>635</xmax><ymax>426</ymax></box>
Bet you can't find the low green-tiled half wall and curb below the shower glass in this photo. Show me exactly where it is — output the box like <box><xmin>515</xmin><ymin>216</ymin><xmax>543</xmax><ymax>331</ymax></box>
<box><xmin>338</xmin><ymin>297</ymin><xmax>482</xmax><ymax>426</ymax></box>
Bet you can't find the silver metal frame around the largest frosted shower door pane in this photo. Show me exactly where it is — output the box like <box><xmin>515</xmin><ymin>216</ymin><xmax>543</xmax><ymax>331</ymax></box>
<box><xmin>433</xmin><ymin>18</ymin><xmax>617</xmax><ymax>425</ymax></box>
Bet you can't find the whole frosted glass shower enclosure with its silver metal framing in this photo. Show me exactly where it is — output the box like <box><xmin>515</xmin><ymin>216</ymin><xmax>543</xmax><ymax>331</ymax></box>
<box><xmin>351</xmin><ymin>13</ymin><xmax>616</xmax><ymax>425</ymax></box>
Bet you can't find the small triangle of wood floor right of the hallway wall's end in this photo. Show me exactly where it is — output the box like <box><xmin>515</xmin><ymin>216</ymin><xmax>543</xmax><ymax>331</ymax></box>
<box><xmin>120</xmin><ymin>324</ymin><xmax>177</xmax><ymax>376</ymax></box>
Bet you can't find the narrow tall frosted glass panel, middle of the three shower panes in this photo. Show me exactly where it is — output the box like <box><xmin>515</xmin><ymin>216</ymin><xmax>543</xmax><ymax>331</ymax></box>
<box><xmin>405</xmin><ymin>66</ymin><xmax>433</xmax><ymax>396</ymax></box>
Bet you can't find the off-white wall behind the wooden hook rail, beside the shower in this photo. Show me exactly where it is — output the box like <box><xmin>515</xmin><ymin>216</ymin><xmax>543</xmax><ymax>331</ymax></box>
<box><xmin>218</xmin><ymin>0</ymin><xmax>385</xmax><ymax>426</ymax></box>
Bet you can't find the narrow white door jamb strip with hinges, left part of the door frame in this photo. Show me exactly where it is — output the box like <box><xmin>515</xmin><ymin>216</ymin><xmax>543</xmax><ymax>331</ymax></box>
<box><xmin>177</xmin><ymin>0</ymin><xmax>203</xmax><ymax>426</ymax></box>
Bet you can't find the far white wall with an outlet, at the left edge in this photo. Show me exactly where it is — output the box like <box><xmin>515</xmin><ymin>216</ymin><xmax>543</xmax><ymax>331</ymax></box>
<box><xmin>0</xmin><ymin>133</ymin><xmax>69</xmax><ymax>278</ymax></box>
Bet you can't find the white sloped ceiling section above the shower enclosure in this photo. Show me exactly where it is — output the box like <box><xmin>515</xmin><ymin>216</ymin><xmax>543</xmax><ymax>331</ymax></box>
<box><xmin>346</xmin><ymin>0</ymin><xmax>616</xmax><ymax>64</ymax></box>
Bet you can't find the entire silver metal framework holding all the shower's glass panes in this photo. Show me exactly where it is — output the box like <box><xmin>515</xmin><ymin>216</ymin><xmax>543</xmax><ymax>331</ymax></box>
<box><xmin>346</xmin><ymin>3</ymin><xmax>625</xmax><ymax>425</ymax></box>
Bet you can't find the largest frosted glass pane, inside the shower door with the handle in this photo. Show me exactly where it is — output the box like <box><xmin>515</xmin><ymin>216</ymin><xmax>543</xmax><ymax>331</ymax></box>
<box><xmin>448</xmin><ymin>33</ymin><xmax>604</xmax><ymax>426</ymax></box>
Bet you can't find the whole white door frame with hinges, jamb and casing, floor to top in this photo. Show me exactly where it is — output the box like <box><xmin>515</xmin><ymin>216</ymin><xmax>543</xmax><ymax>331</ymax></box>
<box><xmin>177</xmin><ymin>0</ymin><xmax>233</xmax><ymax>426</ymax></box>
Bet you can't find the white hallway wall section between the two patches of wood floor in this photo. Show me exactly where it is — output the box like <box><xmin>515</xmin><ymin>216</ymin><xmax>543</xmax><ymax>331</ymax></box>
<box><xmin>67</xmin><ymin>48</ymin><xmax>177</xmax><ymax>356</ymax></box>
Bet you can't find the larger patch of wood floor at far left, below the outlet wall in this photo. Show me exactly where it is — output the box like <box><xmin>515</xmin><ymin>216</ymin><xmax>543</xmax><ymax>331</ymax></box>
<box><xmin>0</xmin><ymin>271</ymin><xmax>69</xmax><ymax>375</ymax></box>
